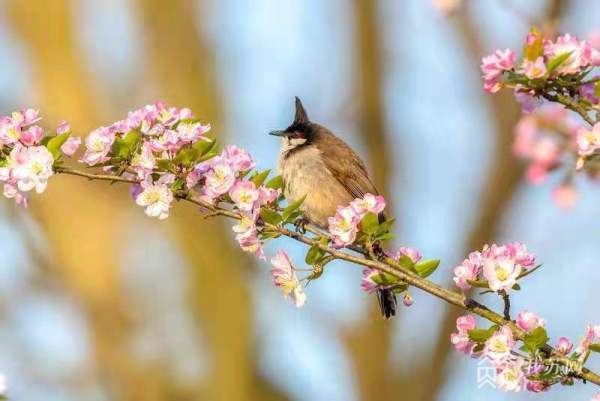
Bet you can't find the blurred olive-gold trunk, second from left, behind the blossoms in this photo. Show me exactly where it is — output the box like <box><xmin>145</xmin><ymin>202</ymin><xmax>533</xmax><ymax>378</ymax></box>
<box><xmin>138</xmin><ymin>0</ymin><xmax>286</xmax><ymax>401</ymax></box>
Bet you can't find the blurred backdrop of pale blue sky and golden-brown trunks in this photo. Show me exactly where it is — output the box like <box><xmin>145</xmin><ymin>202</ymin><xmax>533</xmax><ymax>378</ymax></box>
<box><xmin>0</xmin><ymin>0</ymin><xmax>600</xmax><ymax>401</ymax></box>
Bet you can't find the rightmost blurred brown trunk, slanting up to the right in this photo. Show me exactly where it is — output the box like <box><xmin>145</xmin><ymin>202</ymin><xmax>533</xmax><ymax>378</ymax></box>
<box><xmin>397</xmin><ymin>0</ymin><xmax>569</xmax><ymax>401</ymax></box>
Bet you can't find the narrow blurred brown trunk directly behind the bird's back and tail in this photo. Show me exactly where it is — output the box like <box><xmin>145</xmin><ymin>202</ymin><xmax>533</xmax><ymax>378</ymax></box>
<box><xmin>343</xmin><ymin>0</ymin><xmax>401</xmax><ymax>401</ymax></box>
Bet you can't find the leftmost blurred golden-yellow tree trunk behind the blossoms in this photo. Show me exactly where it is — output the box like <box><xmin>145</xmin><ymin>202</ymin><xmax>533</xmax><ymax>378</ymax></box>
<box><xmin>8</xmin><ymin>0</ymin><xmax>181</xmax><ymax>401</ymax></box>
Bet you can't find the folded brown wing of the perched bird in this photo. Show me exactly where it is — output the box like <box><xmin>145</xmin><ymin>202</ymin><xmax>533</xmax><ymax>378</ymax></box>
<box><xmin>323</xmin><ymin>136</ymin><xmax>379</xmax><ymax>198</ymax></box>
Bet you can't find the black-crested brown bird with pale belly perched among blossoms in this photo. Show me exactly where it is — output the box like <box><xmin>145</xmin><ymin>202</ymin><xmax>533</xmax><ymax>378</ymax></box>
<box><xmin>269</xmin><ymin>96</ymin><xmax>397</xmax><ymax>319</ymax></box>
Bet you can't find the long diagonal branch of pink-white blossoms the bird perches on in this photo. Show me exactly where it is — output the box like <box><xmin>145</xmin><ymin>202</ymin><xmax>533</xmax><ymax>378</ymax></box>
<box><xmin>0</xmin><ymin>103</ymin><xmax>600</xmax><ymax>391</ymax></box>
